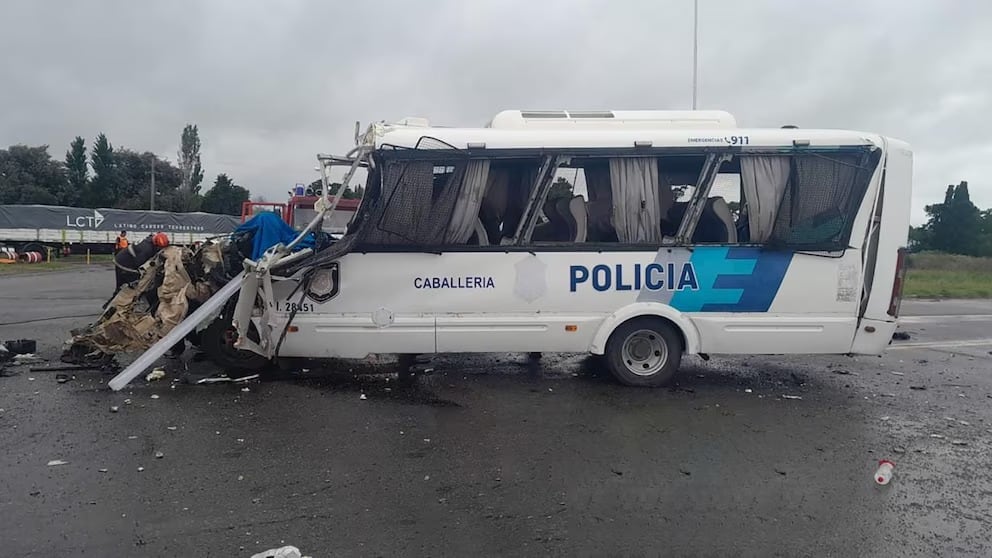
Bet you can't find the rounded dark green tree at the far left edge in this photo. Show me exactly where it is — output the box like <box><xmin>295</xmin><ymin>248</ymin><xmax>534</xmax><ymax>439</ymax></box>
<box><xmin>0</xmin><ymin>145</ymin><xmax>65</xmax><ymax>205</ymax></box>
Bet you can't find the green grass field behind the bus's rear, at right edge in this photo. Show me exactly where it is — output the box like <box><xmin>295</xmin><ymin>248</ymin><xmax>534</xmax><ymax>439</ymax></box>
<box><xmin>903</xmin><ymin>252</ymin><xmax>992</xmax><ymax>298</ymax></box>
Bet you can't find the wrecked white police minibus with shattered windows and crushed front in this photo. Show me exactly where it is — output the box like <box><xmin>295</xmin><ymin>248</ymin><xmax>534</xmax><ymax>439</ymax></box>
<box><xmin>110</xmin><ymin>111</ymin><xmax>912</xmax><ymax>386</ymax></box>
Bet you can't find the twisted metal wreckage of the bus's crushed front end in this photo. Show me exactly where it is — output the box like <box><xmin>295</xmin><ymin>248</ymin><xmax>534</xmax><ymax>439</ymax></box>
<box><xmin>75</xmin><ymin>124</ymin><xmax>380</xmax><ymax>391</ymax></box>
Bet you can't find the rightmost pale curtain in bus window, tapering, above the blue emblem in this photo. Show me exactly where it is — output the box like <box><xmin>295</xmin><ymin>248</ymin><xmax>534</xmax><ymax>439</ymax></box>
<box><xmin>741</xmin><ymin>155</ymin><xmax>790</xmax><ymax>242</ymax></box>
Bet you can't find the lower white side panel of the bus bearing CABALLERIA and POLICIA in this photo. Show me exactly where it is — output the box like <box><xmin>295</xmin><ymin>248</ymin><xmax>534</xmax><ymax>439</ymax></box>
<box><xmin>277</xmin><ymin>246</ymin><xmax>857</xmax><ymax>357</ymax></box>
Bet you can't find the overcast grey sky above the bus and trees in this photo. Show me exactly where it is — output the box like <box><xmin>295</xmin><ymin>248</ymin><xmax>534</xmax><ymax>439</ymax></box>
<box><xmin>0</xmin><ymin>0</ymin><xmax>992</xmax><ymax>223</ymax></box>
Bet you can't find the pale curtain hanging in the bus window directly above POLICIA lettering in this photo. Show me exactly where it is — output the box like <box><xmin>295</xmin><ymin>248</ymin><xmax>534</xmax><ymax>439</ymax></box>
<box><xmin>610</xmin><ymin>157</ymin><xmax>662</xmax><ymax>244</ymax></box>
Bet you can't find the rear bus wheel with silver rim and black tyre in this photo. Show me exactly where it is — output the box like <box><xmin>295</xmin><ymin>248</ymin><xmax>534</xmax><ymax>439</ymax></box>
<box><xmin>606</xmin><ymin>317</ymin><xmax>682</xmax><ymax>387</ymax></box>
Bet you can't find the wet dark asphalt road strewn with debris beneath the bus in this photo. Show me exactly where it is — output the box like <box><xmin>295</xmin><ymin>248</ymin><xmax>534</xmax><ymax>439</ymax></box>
<box><xmin>0</xmin><ymin>268</ymin><xmax>992</xmax><ymax>557</ymax></box>
